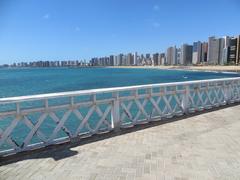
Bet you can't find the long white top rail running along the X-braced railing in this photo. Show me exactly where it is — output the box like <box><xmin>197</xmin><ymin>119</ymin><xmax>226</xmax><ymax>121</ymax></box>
<box><xmin>0</xmin><ymin>77</ymin><xmax>240</xmax><ymax>104</ymax></box>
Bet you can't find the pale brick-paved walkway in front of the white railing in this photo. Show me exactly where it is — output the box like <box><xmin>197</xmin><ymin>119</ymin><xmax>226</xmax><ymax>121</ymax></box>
<box><xmin>0</xmin><ymin>105</ymin><xmax>240</xmax><ymax>180</ymax></box>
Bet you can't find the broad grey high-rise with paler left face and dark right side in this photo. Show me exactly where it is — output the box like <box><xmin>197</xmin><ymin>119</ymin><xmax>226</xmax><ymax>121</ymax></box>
<box><xmin>180</xmin><ymin>44</ymin><xmax>193</xmax><ymax>65</ymax></box>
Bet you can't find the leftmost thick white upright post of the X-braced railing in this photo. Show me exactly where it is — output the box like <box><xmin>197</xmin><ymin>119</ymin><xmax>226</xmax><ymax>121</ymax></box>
<box><xmin>111</xmin><ymin>92</ymin><xmax>121</xmax><ymax>132</ymax></box>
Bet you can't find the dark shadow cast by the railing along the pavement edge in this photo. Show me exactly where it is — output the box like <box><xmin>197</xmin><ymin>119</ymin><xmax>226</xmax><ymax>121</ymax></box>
<box><xmin>0</xmin><ymin>103</ymin><xmax>240</xmax><ymax>166</ymax></box>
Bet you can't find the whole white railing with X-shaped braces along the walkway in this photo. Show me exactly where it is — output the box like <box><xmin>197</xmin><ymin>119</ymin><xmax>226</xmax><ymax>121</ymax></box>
<box><xmin>0</xmin><ymin>78</ymin><xmax>240</xmax><ymax>155</ymax></box>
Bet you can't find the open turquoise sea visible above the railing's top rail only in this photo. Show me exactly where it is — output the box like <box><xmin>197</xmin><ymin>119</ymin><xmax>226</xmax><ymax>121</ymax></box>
<box><xmin>0</xmin><ymin>68</ymin><xmax>240</xmax><ymax>98</ymax></box>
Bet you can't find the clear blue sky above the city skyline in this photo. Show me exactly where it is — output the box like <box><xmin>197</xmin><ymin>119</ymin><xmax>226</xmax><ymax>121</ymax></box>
<box><xmin>0</xmin><ymin>0</ymin><xmax>240</xmax><ymax>64</ymax></box>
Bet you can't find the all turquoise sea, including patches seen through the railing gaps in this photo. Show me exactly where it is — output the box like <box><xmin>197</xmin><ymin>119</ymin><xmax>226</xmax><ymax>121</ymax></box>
<box><xmin>0</xmin><ymin>68</ymin><xmax>240</xmax><ymax>152</ymax></box>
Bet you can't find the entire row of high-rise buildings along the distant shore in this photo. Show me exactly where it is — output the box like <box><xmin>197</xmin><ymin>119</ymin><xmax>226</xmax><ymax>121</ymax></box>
<box><xmin>0</xmin><ymin>35</ymin><xmax>240</xmax><ymax>67</ymax></box>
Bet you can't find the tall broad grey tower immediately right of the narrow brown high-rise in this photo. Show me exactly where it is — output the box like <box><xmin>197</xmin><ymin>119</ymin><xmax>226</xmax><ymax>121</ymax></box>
<box><xmin>207</xmin><ymin>37</ymin><xmax>220</xmax><ymax>65</ymax></box>
